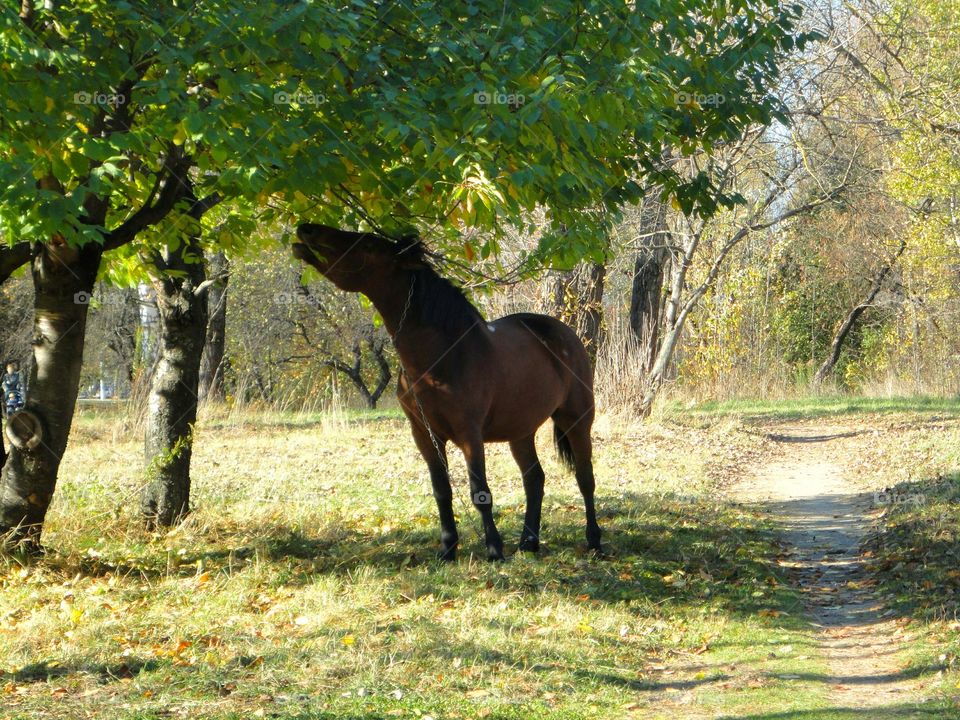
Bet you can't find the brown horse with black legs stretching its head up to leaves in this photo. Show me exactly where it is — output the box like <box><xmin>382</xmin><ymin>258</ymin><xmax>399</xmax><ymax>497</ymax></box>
<box><xmin>293</xmin><ymin>224</ymin><xmax>600</xmax><ymax>560</ymax></box>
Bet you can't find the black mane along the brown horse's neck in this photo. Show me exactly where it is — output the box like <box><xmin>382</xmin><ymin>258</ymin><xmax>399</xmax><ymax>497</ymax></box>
<box><xmin>397</xmin><ymin>235</ymin><xmax>484</xmax><ymax>335</ymax></box>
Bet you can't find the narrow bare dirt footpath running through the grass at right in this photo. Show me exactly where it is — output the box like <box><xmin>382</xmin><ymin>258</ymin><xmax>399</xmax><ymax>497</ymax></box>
<box><xmin>734</xmin><ymin>425</ymin><xmax>914</xmax><ymax>709</ymax></box>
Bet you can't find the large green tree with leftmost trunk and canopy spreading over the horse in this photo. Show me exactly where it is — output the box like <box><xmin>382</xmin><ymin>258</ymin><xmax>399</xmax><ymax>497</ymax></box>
<box><xmin>0</xmin><ymin>0</ymin><xmax>808</xmax><ymax>546</ymax></box>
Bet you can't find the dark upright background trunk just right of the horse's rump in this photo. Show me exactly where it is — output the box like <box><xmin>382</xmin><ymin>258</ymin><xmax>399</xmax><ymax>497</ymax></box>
<box><xmin>630</xmin><ymin>196</ymin><xmax>670</xmax><ymax>373</ymax></box>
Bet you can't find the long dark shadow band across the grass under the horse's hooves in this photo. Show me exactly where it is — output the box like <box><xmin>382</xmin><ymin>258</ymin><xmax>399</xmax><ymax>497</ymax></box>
<box><xmin>33</xmin><ymin>493</ymin><xmax>798</xmax><ymax>614</ymax></box>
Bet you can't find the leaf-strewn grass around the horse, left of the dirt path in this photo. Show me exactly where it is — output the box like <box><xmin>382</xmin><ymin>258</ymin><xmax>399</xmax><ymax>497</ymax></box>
<box><xmin>0</xmin><ymin>408</ymin><xmax>946</xmax><ymax>720</ymax></box>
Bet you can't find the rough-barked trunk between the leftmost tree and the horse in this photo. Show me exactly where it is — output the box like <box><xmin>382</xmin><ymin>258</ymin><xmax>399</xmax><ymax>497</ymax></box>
<box><xmin>141</xmin><ymin>205</ymin><xmax>207</xmax><ymax>529</ymax></box>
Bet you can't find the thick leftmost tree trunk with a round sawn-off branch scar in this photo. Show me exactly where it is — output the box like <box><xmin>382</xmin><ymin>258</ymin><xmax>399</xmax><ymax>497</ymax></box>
<box><xmin>0</xmin><ymin>238</ymin><xmax>102</xmax><ymax>551</ymax></box>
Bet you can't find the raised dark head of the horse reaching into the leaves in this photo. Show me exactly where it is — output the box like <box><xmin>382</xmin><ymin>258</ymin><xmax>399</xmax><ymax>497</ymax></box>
<box><xmin>293</xmin><ymin>223</ymin><xmax>426</xmax><ymax>292</ymax></box>
